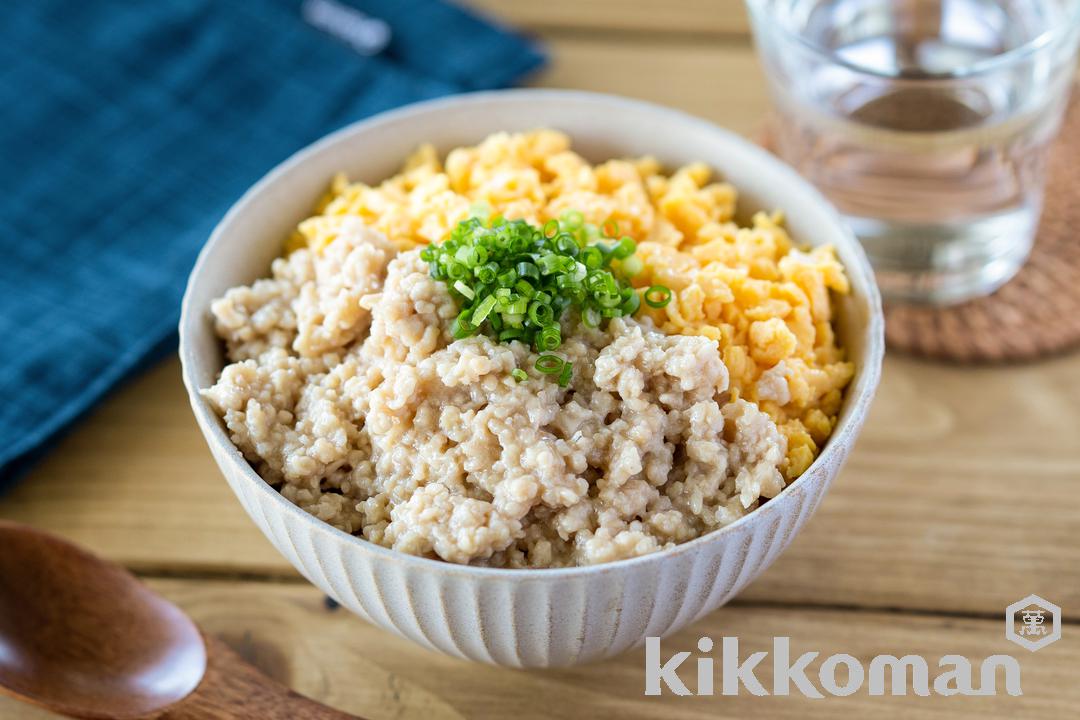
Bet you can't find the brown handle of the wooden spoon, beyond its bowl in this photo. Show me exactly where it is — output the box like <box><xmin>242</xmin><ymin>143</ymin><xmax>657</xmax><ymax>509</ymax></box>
<box><xmin>158</xmin><ymin>635</ymin><xmax>363</xmax><ymax>720</ymax></box>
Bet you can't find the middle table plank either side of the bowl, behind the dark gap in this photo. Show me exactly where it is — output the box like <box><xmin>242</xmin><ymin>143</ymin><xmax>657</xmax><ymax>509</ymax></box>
<box><xmin>0</xmin><ymin>357</ymin><xmax>1080</xmax><ymax>615</ymax></box>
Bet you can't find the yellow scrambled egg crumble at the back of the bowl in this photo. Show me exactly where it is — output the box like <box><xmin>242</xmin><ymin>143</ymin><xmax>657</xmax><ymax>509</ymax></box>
<box><xmin>289</xmin><ymin>130</ymin><xmax>854</xmax><ymax>480</ymax></box>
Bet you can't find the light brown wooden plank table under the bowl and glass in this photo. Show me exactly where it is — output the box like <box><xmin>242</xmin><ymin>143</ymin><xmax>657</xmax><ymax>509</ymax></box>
<box><xmin>0</xmin><ymin>0</ymin><xmax>1080</xmax><ymax>720</ymax></box>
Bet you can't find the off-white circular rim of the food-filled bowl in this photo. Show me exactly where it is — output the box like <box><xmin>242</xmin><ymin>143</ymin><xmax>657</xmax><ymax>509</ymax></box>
<box><xmin>179</xmin><ymin>89</ymin><xmax>885</xmax><ymax>581</ymax></box>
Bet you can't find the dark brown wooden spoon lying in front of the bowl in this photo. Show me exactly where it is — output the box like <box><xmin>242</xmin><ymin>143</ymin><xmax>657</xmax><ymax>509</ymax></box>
<box><xmin>0</xmin><ymin>521</ymin><xmax>357</xmax><ymax>720</ymax></box>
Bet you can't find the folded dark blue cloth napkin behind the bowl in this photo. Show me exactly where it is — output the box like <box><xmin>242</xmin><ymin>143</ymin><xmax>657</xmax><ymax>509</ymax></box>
<box><xmin>0</xmin><ymin>0</ymin><xmax>542</xmax><ymax>486</ymax></box>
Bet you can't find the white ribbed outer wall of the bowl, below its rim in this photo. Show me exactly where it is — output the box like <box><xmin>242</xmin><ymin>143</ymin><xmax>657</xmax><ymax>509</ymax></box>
<box><xmin>206</xmin><ymin>427</ymin><xmax>829</xmax><ymax>667</ymax></box>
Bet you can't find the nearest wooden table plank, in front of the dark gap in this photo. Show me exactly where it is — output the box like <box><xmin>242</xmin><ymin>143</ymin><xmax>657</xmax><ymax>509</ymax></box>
<box><xmin>0</xmin><ymin>580</ymin><xmax>1080</xmax><ymax>720</ymax></box>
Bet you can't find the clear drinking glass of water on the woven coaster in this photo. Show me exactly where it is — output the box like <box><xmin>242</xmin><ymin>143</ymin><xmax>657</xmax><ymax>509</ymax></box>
<box><xmin>747</xmin><ymin>0</ymin><xmax>1080</xmax><ymax>303</ymax></box>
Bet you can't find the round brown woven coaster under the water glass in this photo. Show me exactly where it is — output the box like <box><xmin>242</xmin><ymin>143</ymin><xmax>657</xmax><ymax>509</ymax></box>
<box><xmin>762</xmin><ymin>89</ymin><xmax>1080</xmax><ymax>363</ymax></box>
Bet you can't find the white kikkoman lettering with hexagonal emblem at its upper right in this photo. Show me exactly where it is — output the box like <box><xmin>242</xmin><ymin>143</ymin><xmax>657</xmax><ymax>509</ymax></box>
<box><xmin>645</xmin><ymin>595</ymin><xmax>1062</xmax><ymax>698</ymax></box>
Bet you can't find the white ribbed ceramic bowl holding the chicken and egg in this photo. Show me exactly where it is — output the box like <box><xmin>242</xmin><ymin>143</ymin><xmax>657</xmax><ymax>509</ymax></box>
<box><xmin>180</xmin><ymin>90</ymin><xmax>883</xmax><ymax>667</ymax></box>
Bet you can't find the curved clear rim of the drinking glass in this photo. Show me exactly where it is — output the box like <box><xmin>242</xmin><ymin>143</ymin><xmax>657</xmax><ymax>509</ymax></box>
<box><xmin>746</xmin><ymin>0</ymin><xmax>1080</xmax><ymax>82</ymax></box>
